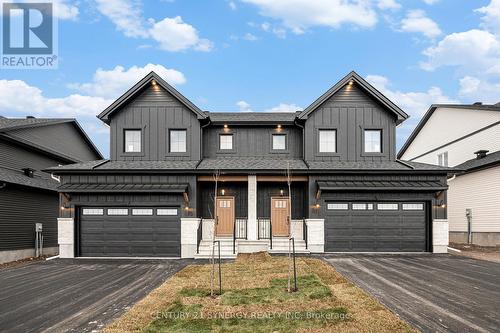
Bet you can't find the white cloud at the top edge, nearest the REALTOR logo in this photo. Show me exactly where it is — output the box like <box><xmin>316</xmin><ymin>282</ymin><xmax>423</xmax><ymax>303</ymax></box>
<box><xmin>95</xmin><ymin>0</ymin><xmax>213</xmax><ymax>52</ymax></box>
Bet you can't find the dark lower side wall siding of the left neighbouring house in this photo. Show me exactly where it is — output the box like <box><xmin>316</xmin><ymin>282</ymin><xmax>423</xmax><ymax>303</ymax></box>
<box><xmin>0</xmin><ymin>184</ymin><xmax>59</xmax><ymax>250</ymax></box>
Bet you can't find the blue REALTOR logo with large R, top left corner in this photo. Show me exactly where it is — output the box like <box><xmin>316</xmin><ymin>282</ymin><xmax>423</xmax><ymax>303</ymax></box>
<box><xmin>1</xmin><ymin>2</ymin><xmax>57</xmax><ymax>69</ymax></box>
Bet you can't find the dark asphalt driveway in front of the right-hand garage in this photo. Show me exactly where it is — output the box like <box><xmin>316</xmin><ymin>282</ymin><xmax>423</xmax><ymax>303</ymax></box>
<box><xmin>323</xmin><ymin>254</ymin><xmax>500</xmax><ymax>332</ymax></box>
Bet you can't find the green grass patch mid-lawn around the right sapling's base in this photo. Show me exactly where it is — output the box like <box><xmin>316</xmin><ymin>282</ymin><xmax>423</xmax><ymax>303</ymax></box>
<box><xmin>222</xmin><ymin>275</ymin><xmax>332</xmax><ymax>305</ymax></box>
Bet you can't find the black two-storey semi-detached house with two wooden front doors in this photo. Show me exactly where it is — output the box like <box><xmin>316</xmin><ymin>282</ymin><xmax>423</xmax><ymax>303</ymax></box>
<box><xmin>50</xmin><ymin>72</ymin><xmax>450</xmax><ymax>257</ymax></box>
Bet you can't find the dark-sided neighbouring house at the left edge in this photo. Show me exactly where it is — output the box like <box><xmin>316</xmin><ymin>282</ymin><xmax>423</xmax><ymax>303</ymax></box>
<box><xmin>0</xmin><ymin>116</ymin><xmax>102</xmax><ymax>263</ymax></box>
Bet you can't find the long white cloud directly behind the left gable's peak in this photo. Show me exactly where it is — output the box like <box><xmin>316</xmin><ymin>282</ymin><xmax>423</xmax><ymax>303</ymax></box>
<box><xmin>70</xmin><ymin>64</ymin><xmax>186</xmax><ymax>98</ymax></box>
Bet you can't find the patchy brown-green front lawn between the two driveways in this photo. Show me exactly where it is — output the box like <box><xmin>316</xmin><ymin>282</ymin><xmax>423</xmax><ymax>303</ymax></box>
<box><xmin>104</xmin><ymin>254</ymin><xmax>414</xmax><ymax>333</ymax></box>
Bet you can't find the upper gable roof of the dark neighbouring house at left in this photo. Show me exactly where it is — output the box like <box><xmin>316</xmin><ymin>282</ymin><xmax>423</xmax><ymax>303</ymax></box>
<box><xmin>0</xmin><ymin>117</ymin><xmax>103</xmax><ymax>162</ymax></box>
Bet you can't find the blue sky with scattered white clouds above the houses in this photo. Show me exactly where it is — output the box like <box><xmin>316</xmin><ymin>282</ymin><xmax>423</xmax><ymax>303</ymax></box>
<box><xmin>0</xmin><ymin>0</ymin><xmax>500</xmax><ymax>156</ymax></box>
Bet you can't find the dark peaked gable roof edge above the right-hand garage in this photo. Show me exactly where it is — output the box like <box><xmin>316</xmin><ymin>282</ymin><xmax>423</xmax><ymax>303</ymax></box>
<box><xmin>298</xmin><ymin>71</ymin><xmax>409</xmax><ymax>124</ymax></box>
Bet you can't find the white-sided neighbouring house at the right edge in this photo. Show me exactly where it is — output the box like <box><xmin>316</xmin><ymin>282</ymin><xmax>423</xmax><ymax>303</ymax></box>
<box><xmin>398</xmin><ymin>103</ymin><xmax>500</xmax><ymax>246</ymax></box>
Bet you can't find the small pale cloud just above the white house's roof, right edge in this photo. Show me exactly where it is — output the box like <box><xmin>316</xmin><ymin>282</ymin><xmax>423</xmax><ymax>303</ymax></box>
<box><xmin>459</xmin><ymin>76</ymin><xmax>500</xmax><ymax>104</ymax></box>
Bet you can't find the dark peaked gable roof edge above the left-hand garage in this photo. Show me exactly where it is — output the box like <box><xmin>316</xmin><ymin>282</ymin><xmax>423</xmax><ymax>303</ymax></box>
<box><xmin>97</xmin><ymin>72</ymin><xmax>207</xmax><ymax>125</ymax></box>
